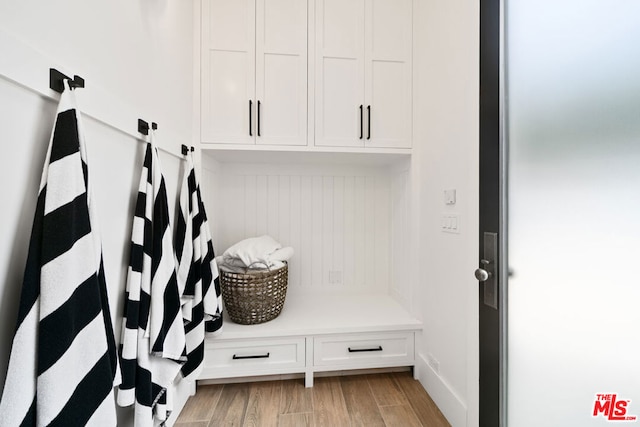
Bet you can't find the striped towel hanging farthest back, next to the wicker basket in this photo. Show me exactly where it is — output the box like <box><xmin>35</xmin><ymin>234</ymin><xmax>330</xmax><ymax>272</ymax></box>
<box><xmin>176</xmin><ymin>151</ymin><xmax>222</xmax><ymax>380</ymax></box>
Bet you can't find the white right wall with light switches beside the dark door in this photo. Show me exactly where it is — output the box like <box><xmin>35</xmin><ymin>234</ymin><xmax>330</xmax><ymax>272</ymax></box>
<box><xmin>414</xmin><ymin>0</ymin><xmax>479</xmax><ymax>426</ymax></box>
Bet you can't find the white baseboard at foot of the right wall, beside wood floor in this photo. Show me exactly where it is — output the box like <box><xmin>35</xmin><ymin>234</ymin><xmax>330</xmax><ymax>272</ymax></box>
<box><xmin>416</xmin><ymin>354</ymin><xmax>467</xmax><ymax>427</ymax></box>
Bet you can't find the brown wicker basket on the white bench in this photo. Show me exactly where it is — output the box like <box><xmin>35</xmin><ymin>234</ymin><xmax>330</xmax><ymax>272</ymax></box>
<box><xmin>219</xmin><ymin>263</ymin><xmax>288</xmax><ymax>325</ymax></box>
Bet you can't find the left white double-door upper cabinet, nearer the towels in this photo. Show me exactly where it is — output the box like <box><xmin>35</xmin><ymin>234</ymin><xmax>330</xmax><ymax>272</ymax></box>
<box><xmin>201</xmin><ymin>0</ymin><xmax>307</xmax><ymax>145</ymax></box>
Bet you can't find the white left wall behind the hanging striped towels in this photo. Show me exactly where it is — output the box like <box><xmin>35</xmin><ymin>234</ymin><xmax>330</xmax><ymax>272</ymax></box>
<box><xmin>0</xmin><ymin>0</ymin><xmax>193</xmax><ymax>425</ymax></box>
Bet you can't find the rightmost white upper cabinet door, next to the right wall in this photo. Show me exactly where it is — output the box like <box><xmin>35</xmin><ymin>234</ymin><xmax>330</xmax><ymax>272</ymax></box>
<box><xmin>365</xmin><ymin>0</ymin><xmax>413</xmax><ymax>148</ymax></box>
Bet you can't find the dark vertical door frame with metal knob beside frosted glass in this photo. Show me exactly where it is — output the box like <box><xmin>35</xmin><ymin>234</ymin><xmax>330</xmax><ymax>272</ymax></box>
<box><xmin>476</xmin><ymin>0</ymin><xmax>506</xmax><ymax>427</ymax></box>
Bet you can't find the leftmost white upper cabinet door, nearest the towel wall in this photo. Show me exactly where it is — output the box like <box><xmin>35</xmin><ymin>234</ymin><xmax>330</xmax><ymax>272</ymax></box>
<box><xmin>201</xmin><ymin>0</ymin><xmax>256</xmax><ymax>144</ymax></box>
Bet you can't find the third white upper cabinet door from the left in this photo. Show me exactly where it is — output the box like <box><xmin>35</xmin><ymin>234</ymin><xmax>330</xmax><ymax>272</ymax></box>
<box><xmin>314</xmin><ymin>0</ymin><xmax>365</xmax><ymax>147</ymax></box>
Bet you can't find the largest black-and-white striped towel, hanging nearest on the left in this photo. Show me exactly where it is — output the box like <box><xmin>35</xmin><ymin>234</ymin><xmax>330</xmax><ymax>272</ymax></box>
<box><xmin>0</xmin><ymin>84</ymin><xmax>120</xmax><ymax>427</ymax></box>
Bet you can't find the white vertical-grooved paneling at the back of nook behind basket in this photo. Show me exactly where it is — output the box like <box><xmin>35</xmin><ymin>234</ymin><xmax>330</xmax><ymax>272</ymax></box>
<box><xmin>203</xmin><ymin>160</ymin><xmax>408</xmax><ymax>299</ymax></box>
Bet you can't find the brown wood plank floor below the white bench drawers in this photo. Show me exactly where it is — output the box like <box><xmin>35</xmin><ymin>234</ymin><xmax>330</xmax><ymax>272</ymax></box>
<box><xmin>175</xmin><ymin>372</ymin><xmax>449</xmax><ymax>427</ymax></box>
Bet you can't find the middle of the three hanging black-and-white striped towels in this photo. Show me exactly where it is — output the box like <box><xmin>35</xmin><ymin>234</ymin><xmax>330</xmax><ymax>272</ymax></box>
<box><xmin>118</xmin><ymin>131</ymin><xmax>186</xmax><ymax>427</ymax></box>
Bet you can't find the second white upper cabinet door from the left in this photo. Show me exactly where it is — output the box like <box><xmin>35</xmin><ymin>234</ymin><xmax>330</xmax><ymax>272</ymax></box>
<box><xmin>256</xmin><ymin>0</ymin><xmax>307</xmax><ymax>145</ymax></box>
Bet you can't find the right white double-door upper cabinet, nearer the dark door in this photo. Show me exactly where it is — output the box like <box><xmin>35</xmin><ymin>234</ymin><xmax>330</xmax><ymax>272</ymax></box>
<box><xmin>315</xmin><ymin>0</ymin><xmax>412</xmax><ymax>148</ymax></box>
